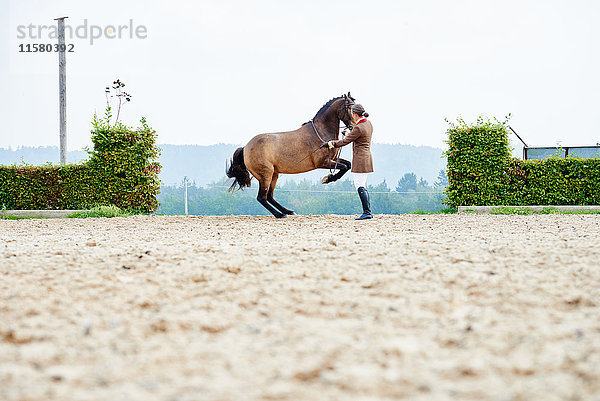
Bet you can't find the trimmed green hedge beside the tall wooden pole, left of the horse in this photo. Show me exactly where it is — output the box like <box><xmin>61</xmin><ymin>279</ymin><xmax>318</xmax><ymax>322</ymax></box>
<box><xmin>0</xmin><ymin>117</ymin><xmax>160</xmax><ymax>213</ymax></box>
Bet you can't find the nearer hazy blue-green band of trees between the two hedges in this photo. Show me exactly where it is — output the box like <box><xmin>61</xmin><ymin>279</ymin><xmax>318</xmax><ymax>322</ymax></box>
<box><xmin>157</xmin><ymin>172</ymin><xmax>447</xmax><ymax>215</ymax></box>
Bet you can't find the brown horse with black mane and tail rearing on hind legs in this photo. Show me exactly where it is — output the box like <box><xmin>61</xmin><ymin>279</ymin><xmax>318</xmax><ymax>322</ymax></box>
<box><xmin>227</xmin><ymin>92</ymin><xmax>354</xmax><ymax>218</ymax></box>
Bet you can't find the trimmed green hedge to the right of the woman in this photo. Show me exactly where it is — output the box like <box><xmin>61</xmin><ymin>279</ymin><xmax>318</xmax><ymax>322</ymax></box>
<box><xmin>445</xmin><ymin>118</ymin><xmax>600</xmax><ymax>207</ymax></box>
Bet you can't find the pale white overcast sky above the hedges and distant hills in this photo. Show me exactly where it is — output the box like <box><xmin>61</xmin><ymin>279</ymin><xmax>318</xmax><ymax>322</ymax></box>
<box><xmin>0</xmin><ymin>0</ymin><xmax>600</xmax><ymax>154</ymax></box>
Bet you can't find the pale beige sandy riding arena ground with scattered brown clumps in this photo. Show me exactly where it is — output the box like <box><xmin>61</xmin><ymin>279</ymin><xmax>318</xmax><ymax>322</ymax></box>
<box><xmin>0</xmin><ymin>215</ymin><xmax>600</xmax><ymax>401</ymax></box>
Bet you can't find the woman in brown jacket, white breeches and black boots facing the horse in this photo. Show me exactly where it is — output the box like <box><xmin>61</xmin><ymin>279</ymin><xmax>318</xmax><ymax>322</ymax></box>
<box><xmin>327</xmin><ymin>104</ymin><xmax>373</xmax><ymax>220</ymax></box>
